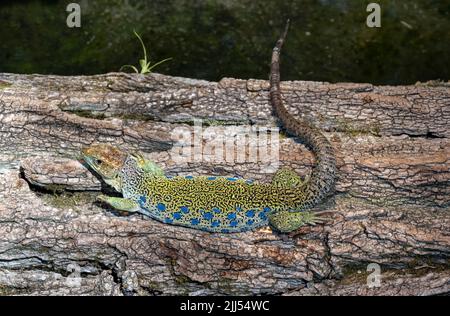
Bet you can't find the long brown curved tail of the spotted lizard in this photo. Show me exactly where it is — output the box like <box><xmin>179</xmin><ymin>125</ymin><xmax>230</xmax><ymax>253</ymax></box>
<box><xmin>270</xmin><ymin>20</ymin><xmax>336</xmax><ymax>210</ymax></box>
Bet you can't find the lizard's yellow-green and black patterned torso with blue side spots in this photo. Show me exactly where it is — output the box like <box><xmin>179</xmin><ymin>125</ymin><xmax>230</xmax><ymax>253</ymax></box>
<box><xmin>121</xmin><ymin>158</ymin><xmax>284</xmax><ymax>233</ymax></box>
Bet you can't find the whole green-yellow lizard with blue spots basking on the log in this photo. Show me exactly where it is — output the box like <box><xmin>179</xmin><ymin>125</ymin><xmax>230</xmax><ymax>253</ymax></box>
<box><xmin>82</xmin><ymin>21</ymin><xmax>335</xmax><ymax>233</ymax></box>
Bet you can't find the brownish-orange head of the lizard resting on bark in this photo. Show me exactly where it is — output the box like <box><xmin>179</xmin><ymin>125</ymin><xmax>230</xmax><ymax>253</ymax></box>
<box><xmin>81</xmin><ymin>144</ymin><xmax>127</xmax><ymax>192</ymax></box>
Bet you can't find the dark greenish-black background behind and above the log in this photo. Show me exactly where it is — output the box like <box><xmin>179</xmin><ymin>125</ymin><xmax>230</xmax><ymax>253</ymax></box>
<box><xmin>0</xmin><ymin>0</ymin><xmax>450</xmax><ymax>84</ymax></box>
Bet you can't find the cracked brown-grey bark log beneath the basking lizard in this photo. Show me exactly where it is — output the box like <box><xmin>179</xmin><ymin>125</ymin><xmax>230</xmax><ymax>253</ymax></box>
<box><xmin>0</xmin><ymin>73</ymin><xmax>450</xmax><ymax>295</ymax></box>
